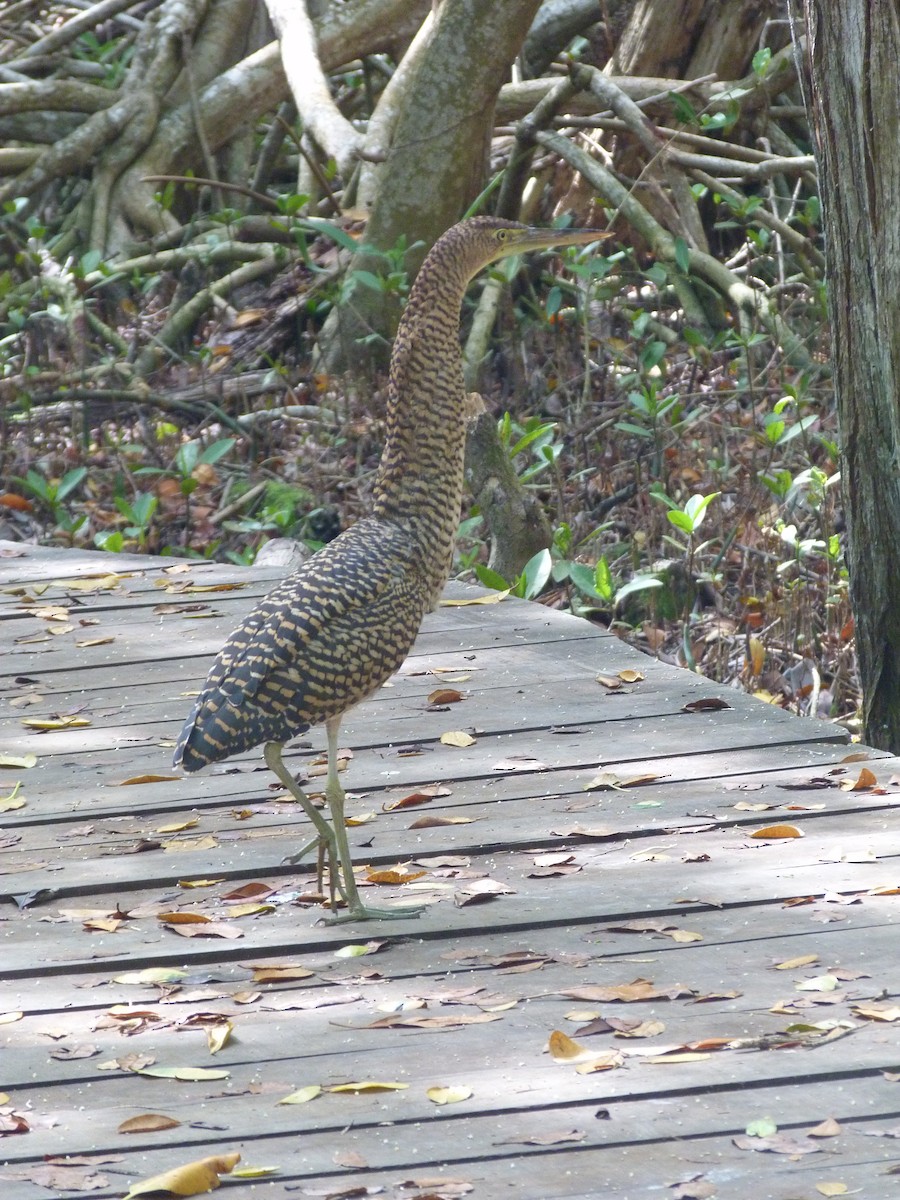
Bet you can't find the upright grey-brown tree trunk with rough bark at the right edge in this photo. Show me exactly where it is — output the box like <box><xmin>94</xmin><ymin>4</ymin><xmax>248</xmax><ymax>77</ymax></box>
<box><xmin>805</xmin><ymin>0</ymin><xmax>900</xmax><ymax>754</ymax></box>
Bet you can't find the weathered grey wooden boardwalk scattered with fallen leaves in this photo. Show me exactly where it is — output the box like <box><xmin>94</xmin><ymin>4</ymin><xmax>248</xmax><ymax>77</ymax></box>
<box><xmin>0</xmin><ymin>544</ymin><xmax>900</xmax><ymax>1200</ymax></box>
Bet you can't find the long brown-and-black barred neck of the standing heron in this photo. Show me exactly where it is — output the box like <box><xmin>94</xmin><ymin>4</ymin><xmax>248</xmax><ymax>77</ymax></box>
<box><xmin>374</xmin><ymin>240</ymin><xmax>469</xmax><ymax>566</ymax></box>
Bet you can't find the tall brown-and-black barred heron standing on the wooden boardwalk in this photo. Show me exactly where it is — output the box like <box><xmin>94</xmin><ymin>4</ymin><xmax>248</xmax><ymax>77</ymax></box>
<box><xmin>174</xmin><ymin>217</ymin><xmax>604</xmax><ymax>920</ymax></box>
